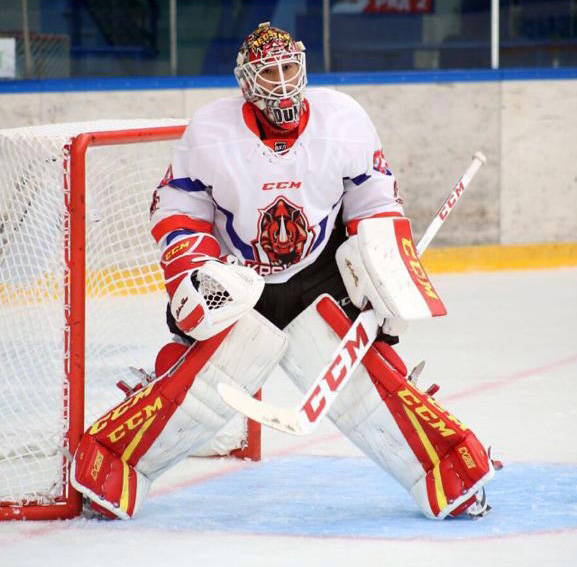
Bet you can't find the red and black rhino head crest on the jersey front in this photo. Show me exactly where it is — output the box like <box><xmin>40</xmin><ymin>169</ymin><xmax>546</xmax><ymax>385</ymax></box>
<box><xmin>252</xmin><ymin>197</ymin><xmax>314</xmax><ymax>271</ymax></box>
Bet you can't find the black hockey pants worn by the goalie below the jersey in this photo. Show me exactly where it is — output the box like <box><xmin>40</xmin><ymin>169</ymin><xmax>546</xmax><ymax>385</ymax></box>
<box><xmin>166</xmin><ymin>222</ymin><xmax>398</xmax><ymax>344</ymax></box>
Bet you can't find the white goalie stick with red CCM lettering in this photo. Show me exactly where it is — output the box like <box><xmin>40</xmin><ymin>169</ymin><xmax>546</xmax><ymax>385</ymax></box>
<box><xmin>217</xmin><ymin>152</ymin><xmax>487</xmax><ymax>435</ymax></box>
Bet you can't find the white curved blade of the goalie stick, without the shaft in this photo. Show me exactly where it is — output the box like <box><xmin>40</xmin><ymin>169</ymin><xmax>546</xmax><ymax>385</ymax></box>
<box><xmin>217</xmin><ymin>382</ymin><xmax>312</xmax><ymax>435</ymax></box>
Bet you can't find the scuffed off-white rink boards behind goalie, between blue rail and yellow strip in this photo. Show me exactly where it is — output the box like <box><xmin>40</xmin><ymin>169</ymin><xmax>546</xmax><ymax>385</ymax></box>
<box><xmin>0</xmin><ymin>73</ymin><xmax>577</xmax><ymax>263</ymax></box>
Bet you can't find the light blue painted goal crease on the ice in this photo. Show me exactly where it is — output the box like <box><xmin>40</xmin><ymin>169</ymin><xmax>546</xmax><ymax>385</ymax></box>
<box><xmin>133</xmin><ymin>456</ymin><xmax>577</xmax><ymax>540</ymax></box>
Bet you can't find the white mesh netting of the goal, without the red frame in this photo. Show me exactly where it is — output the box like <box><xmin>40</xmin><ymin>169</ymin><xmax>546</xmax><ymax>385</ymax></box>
<box><xmin>0</xmin><ymin>121</ymin><xmax>187</xmax><ymax>504</ymax></box>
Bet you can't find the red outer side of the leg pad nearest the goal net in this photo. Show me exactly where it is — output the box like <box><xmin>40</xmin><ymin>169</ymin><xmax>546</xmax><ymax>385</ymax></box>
<box><xmin>71</xmin><ymin>331</ymin><xmax>228</xmax><ymax>520</ymax></box>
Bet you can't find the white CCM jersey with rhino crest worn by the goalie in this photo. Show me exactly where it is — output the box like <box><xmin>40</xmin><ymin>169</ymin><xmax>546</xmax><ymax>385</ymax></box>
<box><xmin>151</xmin><ymin>88</ymin><xmax>403</xmax><ymax>283</ymax></box>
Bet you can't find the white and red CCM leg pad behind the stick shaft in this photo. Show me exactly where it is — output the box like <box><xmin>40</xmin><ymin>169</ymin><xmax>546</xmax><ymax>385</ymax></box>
<box><xmin>281</xmin><ymin>295</ymin><xmax>494</xmax><ymax>519</ymax></box>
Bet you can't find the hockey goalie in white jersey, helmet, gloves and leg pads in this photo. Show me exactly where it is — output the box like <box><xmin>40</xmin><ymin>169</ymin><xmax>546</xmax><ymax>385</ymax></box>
<box><xmin>71</xmin><ymin>23</ymin><xmax>494</xmax><ymax>519</ymax></box>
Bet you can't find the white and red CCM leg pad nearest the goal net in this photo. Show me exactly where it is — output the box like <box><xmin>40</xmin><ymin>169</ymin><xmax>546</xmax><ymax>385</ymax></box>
<box><xmin>71</xmin><ymin>310</ymin><xmax>287</xmax><ymax>519</ymax></box>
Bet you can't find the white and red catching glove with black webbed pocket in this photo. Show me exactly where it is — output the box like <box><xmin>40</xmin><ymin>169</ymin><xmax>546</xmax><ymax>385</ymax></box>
<box><xmin>160</xmin><ymin>233</ymin><xmax>264</xmax><ymax>340</ymax></box>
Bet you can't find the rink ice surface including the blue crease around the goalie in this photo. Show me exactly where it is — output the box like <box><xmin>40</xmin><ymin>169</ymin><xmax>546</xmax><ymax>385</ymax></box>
<box><xmin>0</xmin><ymin>269</ymin><xmax>577</xmax><ymax>567</ymax></box>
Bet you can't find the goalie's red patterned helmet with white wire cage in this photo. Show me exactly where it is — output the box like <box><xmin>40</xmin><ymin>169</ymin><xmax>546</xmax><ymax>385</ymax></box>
<box><xmin>234</xmin><ymin>22</ymin><xmax>307</xmax><ymax>130</ymax></box>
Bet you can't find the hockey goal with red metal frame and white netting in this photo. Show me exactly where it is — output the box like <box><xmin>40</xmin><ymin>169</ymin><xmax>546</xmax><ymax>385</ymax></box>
<box><xmin>0</xmin><ymin>120</ymin><xmax>260</xmax><ymax>519</ymax></box>
